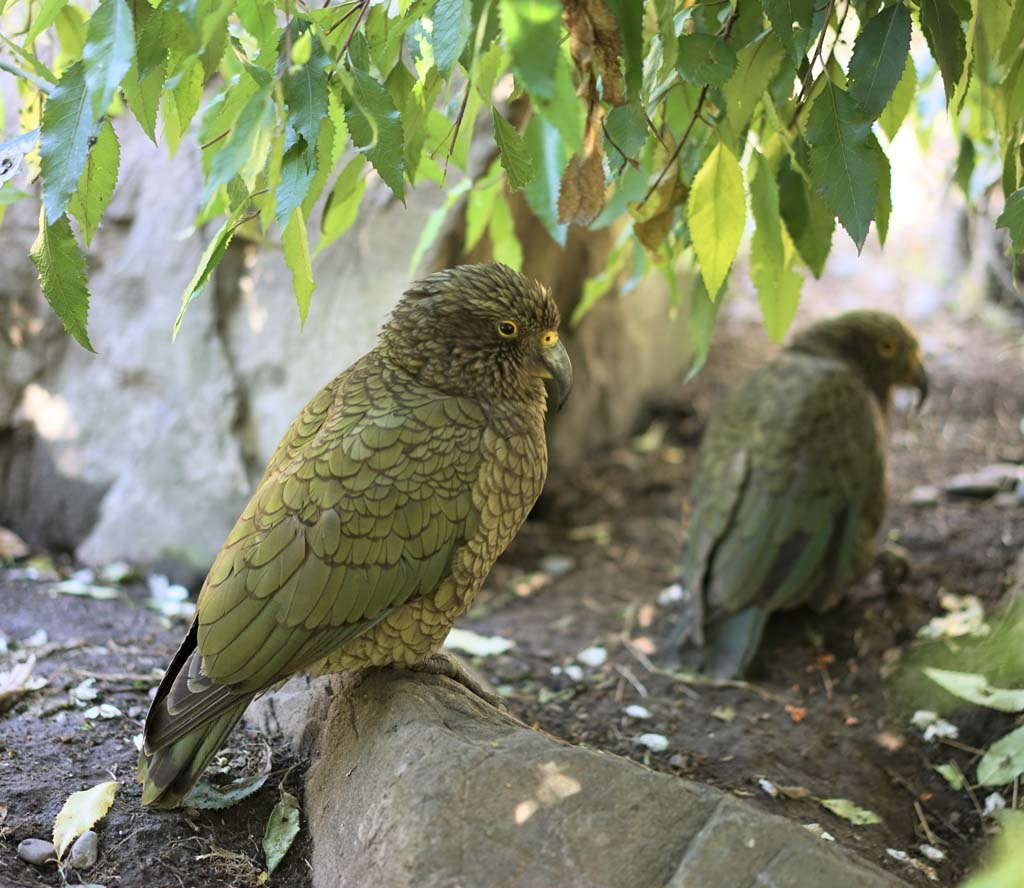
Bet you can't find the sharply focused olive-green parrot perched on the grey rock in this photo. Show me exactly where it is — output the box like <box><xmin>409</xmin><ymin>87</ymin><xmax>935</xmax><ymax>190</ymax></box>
<box><xmin>139</xmin><ymin>264</ymin><xmax>572</xmax><ymax>808</ymax></box>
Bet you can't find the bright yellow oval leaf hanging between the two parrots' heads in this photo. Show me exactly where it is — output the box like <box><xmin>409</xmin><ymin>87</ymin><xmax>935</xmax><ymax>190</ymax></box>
<box><xmin>686</xmin><ymin>142</ymin><xmax>746</xmax><ymax>294</ymax></box>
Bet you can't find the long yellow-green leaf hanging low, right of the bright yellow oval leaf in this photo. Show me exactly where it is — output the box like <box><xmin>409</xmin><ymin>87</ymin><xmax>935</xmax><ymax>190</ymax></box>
<box><xmin>748</xmin><ymin>151</ymin><xmax>804</xmax><ymax>342</ymax></box>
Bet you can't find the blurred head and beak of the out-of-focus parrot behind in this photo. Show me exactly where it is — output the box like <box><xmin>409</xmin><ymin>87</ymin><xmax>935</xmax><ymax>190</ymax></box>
<box><xmin>790</xmin><ymin>309</ymin><xmax>928</xmax><ymax>407</ymax></box>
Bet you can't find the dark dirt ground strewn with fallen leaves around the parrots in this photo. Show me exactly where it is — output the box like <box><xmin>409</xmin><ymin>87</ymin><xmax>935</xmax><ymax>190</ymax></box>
<box><xmin>0</xmin><ymin>301</ymin><xmax>1024</xmax><ymax>888</ymax></box>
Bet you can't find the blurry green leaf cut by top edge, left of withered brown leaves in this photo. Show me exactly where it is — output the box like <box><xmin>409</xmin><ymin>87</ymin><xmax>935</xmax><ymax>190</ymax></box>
<box><xmin>498</xmin><ymin>0</ymin><xmax>562</xmax><ymax>99</ymax></box>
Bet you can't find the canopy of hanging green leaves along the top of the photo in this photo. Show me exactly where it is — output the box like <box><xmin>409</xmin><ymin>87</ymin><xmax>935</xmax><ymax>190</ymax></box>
<box><xmin>0</xmin><ymin>0</ymin><xmax>1024</xmax><ymax>355</ymax></box>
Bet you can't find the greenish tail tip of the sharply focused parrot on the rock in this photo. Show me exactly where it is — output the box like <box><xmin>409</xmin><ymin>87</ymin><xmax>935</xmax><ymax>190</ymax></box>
<box><xmin>138</xmin><ymin>696</ymin><xmax>252</xmax><ymax>808</ymax></box>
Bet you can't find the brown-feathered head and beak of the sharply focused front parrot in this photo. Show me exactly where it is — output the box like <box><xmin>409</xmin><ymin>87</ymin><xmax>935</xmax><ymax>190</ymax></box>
<box><xmin>381</xmin><ymin>263</ymin><xmax>572</xmax><ymax>408</ymax></box>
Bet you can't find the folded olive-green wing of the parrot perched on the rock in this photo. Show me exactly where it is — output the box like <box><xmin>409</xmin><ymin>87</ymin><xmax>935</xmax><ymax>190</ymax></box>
<box><xmin>146</xmin><ymin>368</ymin><xmax>485</xmax><ymax>749</ymax></box>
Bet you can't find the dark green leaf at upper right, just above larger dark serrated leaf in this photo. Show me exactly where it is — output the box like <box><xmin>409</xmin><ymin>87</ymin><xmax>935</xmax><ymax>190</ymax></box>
<box><xmin>849</xmin><ymin>3</ymin><xmax>910</xmax><ymax>120</ymax></box>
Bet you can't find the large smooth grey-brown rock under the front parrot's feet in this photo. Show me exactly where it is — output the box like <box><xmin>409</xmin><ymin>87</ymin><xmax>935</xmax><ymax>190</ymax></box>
<box><xmin>251</xmin><ymin>671</ymin><xmax>903</xmax><ymax>888</ymax></box>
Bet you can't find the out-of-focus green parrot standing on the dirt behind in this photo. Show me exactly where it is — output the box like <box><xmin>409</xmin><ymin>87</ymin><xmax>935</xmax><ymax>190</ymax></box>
<box><xmin>670</xmin><ymin>310</ymin><xmax>928</xmax><ymax>678</ymax></box>
